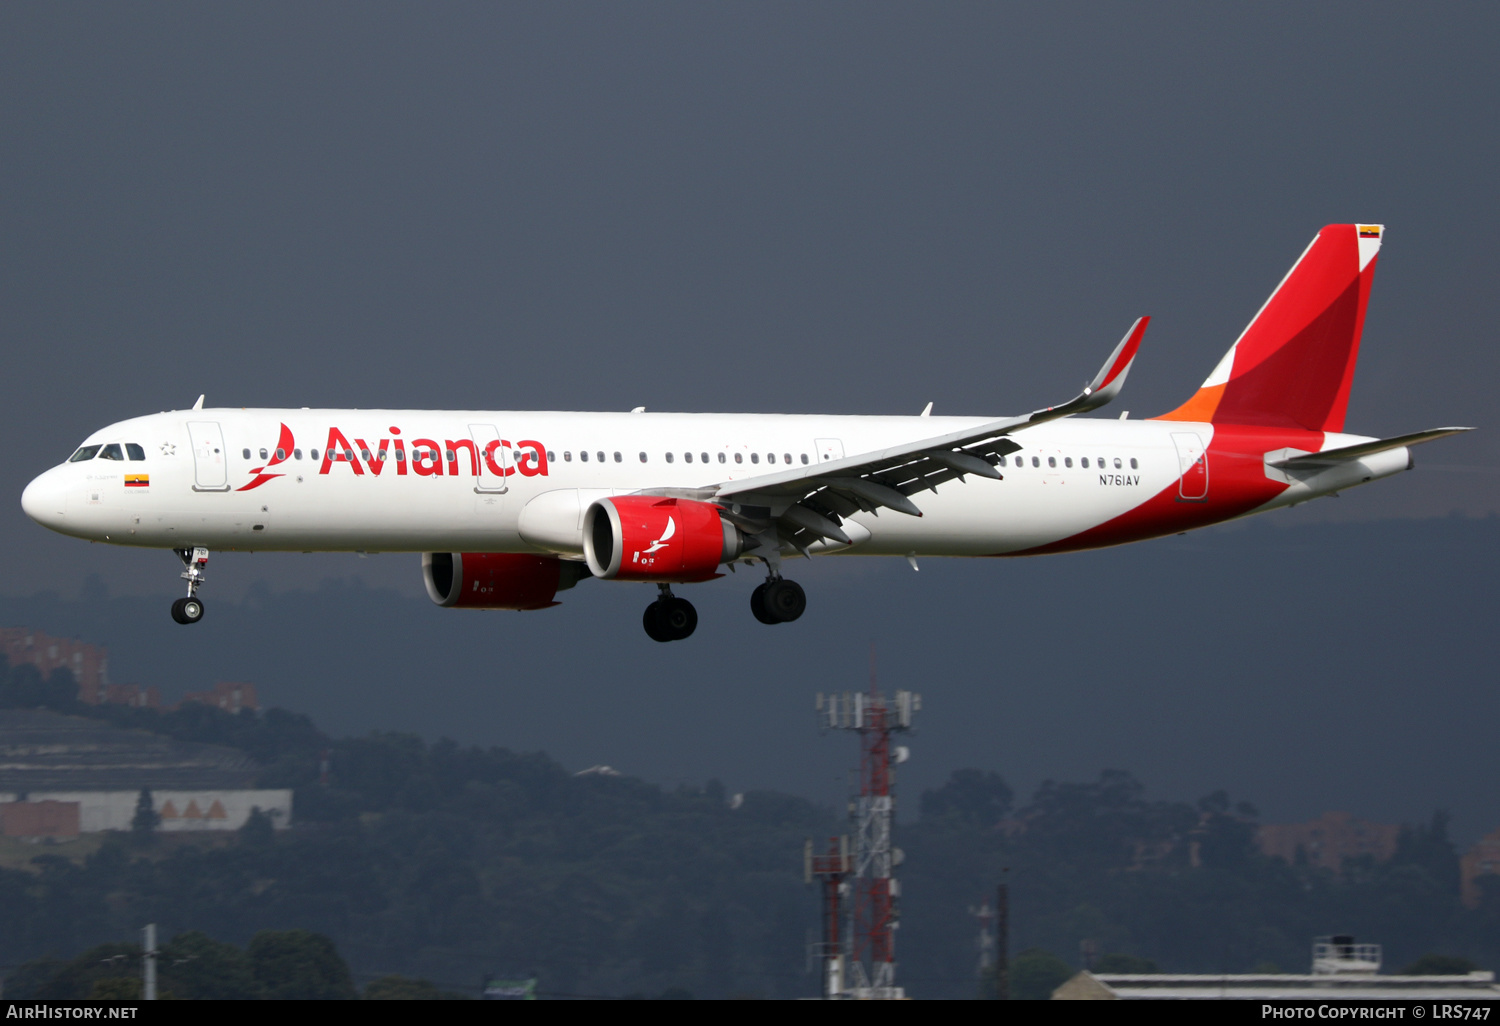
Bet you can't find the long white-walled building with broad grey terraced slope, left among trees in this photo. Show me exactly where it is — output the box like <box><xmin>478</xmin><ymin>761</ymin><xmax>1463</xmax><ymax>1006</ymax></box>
<box><xmin>0</xmin><ymin>710</ymin><xmax>293</xmax><ymax>837</ymax></box>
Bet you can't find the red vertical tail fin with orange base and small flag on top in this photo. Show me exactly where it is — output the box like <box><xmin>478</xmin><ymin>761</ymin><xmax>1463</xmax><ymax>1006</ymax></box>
<box><xmin>1158</xmin><ymin>225</ymin><xmax>1385</xmax><ymax>431</ymax></box>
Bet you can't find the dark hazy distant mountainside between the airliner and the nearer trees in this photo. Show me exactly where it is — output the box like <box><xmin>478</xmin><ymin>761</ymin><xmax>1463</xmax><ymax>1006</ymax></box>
<box><xmin>0</xmin><ymin>513</ymin><xmax>1500</xmax><ymax>842</ymax></box>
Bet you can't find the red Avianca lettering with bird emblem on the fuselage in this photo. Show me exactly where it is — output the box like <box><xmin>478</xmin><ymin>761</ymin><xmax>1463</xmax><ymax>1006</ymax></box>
<box><xmin>237</xmin><ymin>425</ymin><xmax>548</xmax><ymax>492</ymax></box>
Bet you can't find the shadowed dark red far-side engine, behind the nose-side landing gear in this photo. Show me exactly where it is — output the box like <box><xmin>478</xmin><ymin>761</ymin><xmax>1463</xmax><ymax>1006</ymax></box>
<box><xmin>422</xmin><ymin>552</ymin><xmax>588</xmax><ymax>609</ymax></box>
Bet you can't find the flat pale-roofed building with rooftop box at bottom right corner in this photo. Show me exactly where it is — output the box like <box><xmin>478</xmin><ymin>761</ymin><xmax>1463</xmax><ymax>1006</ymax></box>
<box><xmin>1052</xmin><ymin>936</ymin><xmax>1500</xmax><ymax>1001</ymax></box>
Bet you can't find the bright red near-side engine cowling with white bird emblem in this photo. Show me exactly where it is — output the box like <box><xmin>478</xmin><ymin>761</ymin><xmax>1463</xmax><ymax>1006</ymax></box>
<box><xmin>584</xmin><ymin>495</ymin><xmax>744</xmax><ymax>584</ymax></box>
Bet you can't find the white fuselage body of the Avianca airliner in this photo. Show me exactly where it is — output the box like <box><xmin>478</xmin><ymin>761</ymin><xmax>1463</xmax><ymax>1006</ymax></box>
<box><xmin>23</xmin><ymin>410</ymin><xmax>1407</xmax><ymax>557</ymax></box>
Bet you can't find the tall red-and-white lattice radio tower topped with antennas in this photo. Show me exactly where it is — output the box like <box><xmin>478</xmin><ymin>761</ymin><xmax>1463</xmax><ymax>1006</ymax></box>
<box><xmin>818</xmin><ymin>660</ymin><xmax>923</xmax><ymax>1001</ymax></box>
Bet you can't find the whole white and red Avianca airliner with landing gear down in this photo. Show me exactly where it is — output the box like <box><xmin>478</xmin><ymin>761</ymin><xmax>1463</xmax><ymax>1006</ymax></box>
<box><xmin>21</xmin><ymin>224</ymin><xmax>1469</xmax><ymax>642</ymax></box>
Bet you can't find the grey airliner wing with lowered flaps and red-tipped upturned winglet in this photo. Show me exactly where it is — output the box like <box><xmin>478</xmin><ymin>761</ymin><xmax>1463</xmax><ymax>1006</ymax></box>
<box><xmin>693</xmin><ymin>317</ymin><xmax>1151</xmax><ymax>554</ymax></box>
